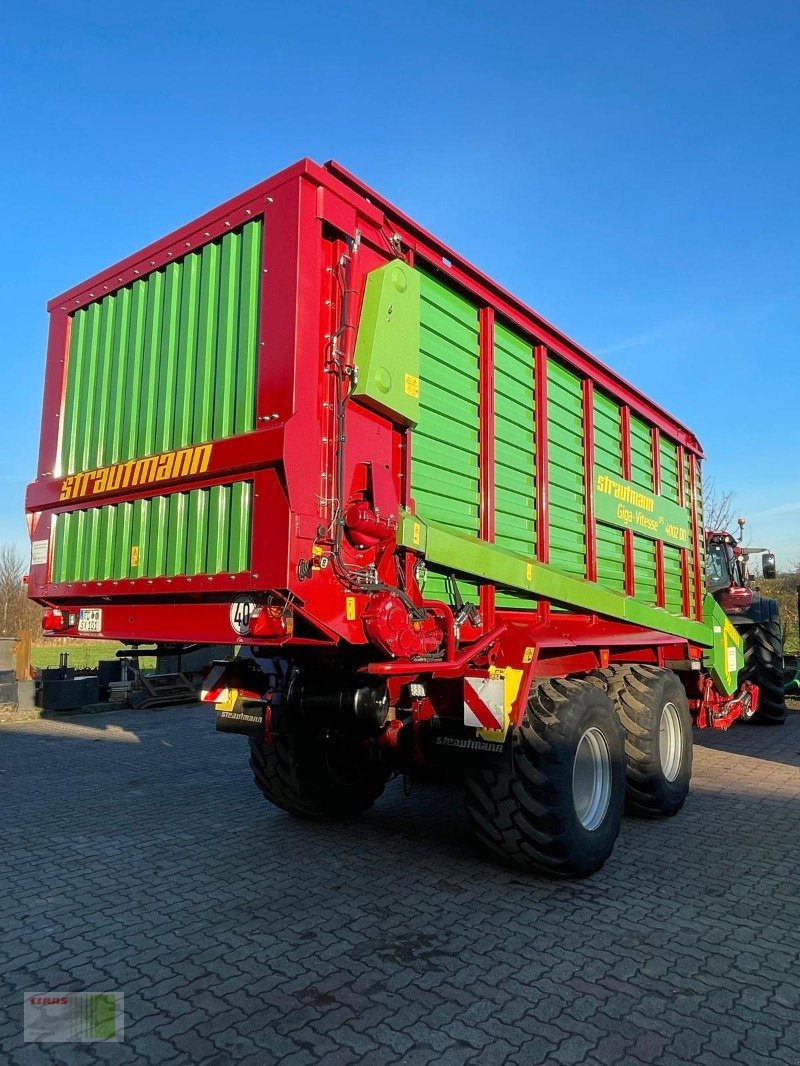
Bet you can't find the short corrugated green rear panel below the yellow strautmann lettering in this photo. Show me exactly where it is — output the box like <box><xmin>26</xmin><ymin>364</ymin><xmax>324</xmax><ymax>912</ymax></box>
<box><xmin>52</xmin><ymin>481</ymin><xmax>252</xmax><ymax>583</ymax></box>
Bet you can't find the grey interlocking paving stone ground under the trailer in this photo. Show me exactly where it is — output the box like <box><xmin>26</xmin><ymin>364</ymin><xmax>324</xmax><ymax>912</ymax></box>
<box><xmin>0</xmin><ymin>708</ymin><xmax>800</xmax><ymax>1066</ymax></box>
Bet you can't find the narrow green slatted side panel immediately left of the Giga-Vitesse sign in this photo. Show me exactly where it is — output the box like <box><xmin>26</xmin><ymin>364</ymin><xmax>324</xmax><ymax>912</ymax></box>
<box><xmin>547</xmin><ymin>357</ymin><xmax>586</xmax><ymax>577</ymax></box>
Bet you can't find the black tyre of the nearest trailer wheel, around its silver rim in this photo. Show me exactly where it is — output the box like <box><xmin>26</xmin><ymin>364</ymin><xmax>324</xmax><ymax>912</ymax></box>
<box><xmin>466</xmin><ymin>678</ymin><xmax>625</xmax><ymax>877</ymax></box>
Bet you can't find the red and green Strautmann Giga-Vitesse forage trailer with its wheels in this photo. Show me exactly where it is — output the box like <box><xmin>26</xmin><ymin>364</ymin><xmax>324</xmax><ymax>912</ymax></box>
<box><xmin>27</xmin><ymin>160</ymin><xmax>785</xmax><ymax>876</ymax></box>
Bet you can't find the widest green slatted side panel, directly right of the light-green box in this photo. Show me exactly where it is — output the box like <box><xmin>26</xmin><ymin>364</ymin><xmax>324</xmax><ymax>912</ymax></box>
<box><xmin>411</xmin><ymin>271</ymin><xmax>479</xmax><ymax>601</ymax></box>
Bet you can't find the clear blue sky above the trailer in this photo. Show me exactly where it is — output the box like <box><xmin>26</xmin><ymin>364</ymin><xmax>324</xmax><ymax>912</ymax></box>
<box><xmin>0</xmin><ymin>0</ymin><xmax>800</xmax><ymax>565</ymax></box>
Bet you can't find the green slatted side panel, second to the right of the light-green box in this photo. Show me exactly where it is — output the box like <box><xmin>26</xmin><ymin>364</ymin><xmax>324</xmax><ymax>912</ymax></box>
<box><xmin>494</xmin><ymin>323</ymin><xmax>537</xmax><ymax>608</ymax></box>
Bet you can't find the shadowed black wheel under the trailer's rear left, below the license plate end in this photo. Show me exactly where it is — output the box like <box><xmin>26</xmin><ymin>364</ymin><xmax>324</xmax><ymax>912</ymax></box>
<box><xmin>250</xmin><ymin>721</ymin><xmax>388</xmax><ymax>819</ymax></box>
